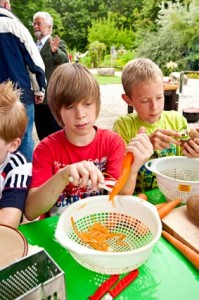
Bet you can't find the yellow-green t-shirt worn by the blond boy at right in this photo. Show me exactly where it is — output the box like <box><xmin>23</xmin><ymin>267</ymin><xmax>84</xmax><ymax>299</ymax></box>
<box><xmin>113</xmin><ymin>110</ymin><xmax>187</xmax><ymax>193</ymax></box>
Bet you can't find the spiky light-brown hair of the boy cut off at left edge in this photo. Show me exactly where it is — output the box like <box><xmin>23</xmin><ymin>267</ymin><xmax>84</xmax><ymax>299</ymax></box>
<box><xmin>0</xmin><ymin>81</ymin><xmax>28</xmax><ymax>143</ymax></box>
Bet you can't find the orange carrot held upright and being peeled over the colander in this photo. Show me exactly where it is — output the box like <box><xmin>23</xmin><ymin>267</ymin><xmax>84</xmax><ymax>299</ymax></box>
<box><xmin>109</xmin><ymin>152</ymin><xmax>133</xmax><ymax>200</ymax></box>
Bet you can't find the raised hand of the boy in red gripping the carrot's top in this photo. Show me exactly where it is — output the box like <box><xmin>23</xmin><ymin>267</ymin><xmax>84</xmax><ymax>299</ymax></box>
<box><xmin>126</xmin><ymin>130</ymin><xmax>153</xmax><ymax>173</ymax></box>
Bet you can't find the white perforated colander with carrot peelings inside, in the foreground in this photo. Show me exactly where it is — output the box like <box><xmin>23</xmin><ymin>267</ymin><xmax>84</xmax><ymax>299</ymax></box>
<box><xmin>55</xmin><ymin>196</ymin><xmax>162</xmax><ymax>274</ymax></box>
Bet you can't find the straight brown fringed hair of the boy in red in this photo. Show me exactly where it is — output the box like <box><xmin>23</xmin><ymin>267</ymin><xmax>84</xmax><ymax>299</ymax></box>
<box><xmin>47</xmin><ymin>63</ymin><xmax>101</xmax><ymax>127</ymax></box>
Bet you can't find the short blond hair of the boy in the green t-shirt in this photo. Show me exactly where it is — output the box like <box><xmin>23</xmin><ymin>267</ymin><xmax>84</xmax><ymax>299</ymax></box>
<box><xmin>122</xmin><ymin>58</ymin><xmax>163</xmax><ymax>97</ymax></box>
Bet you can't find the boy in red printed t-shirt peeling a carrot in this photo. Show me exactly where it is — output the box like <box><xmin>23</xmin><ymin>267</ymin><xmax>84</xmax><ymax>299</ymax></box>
<box><xmin>26</xmin><ymin>63</ymin><xmax>153</xmax><ymax>220</ymax></box>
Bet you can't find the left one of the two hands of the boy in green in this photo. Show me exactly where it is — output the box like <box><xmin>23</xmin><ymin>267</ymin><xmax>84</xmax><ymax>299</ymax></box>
<box><xmin>149</xmin><ymin>129</ymin><xmax>182</xmax><ymax>150</ymax></box>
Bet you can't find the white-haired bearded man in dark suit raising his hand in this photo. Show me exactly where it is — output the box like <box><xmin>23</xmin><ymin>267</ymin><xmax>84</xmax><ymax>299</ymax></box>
<box><xmin>33</xmin><ymin>12</ymin><xmax>69</xmax><ymax>140</ymax></box>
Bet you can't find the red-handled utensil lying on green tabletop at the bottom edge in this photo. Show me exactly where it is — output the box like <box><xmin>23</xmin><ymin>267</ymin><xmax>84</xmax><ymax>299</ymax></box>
<box><xmin>89</xmin><ymin>269</ymin><xmax>139</xmax><ymax>300</ymax></box>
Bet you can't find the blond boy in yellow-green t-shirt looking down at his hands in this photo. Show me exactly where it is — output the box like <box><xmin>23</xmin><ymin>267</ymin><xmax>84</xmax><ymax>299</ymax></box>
<box><xmin>113</xmin><ymin>58</ymin><xmax>199</xmax><ymax>192</ymax></box>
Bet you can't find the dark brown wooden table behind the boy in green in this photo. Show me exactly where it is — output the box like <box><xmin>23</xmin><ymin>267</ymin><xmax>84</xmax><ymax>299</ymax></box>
<box><xmin>128</xmin><ymin>83</ymin><xmax>179</xmax><ymax>114</ymax></box>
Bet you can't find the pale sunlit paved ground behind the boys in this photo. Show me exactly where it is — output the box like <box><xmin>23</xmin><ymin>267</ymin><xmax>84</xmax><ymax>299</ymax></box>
<box><xmin>33</xmin><ymin>74</ymin><xmax>199</xmax><ymax>144</ymax></box>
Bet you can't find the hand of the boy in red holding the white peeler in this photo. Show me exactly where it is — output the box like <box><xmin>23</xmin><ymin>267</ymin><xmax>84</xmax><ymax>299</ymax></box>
<box><xmin>60</xmin><ymin>161</ymin><xmax>104</xmax><ymax>190</ymax></box>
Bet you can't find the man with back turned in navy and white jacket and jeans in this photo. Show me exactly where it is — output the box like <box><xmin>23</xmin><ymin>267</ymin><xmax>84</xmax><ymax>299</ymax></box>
<box><xmin>0</xmin><ymin>0</ymin><xmax>46</xmax><ymax>160</ymax></box>
